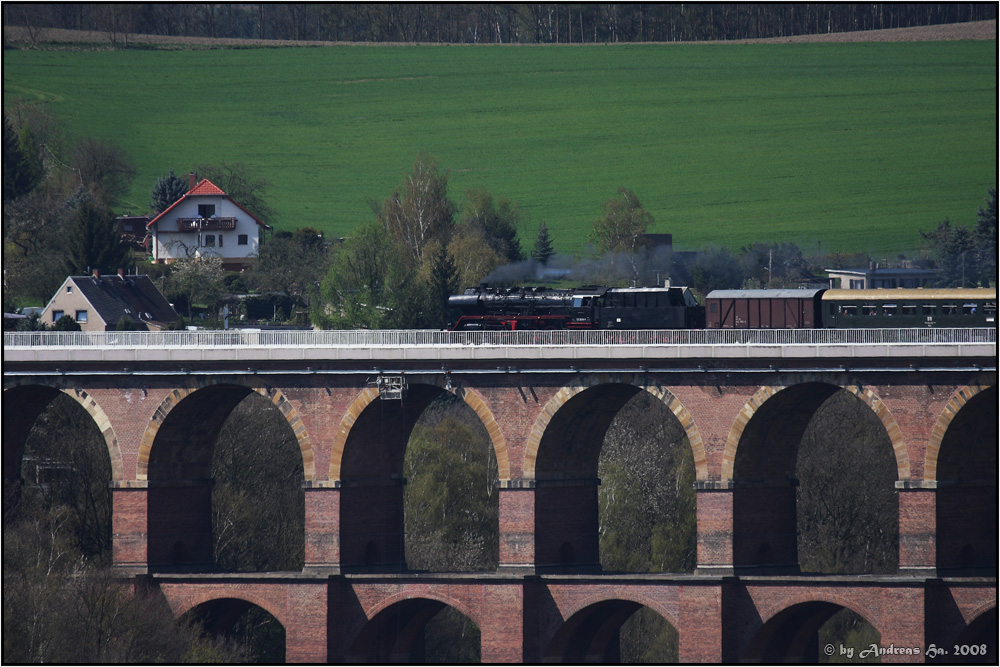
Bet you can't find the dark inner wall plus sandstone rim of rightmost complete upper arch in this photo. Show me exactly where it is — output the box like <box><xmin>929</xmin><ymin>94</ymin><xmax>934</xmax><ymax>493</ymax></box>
<box><xmin>722</xmin><ymin>377</ymin><xmax>910</xmax><ymax>574</ymax></box>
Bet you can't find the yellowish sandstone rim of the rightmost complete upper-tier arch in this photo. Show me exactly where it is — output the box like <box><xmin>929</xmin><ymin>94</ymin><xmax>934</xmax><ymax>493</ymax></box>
<box><xmin>722</xmin><ymin>378</ymin><xmax>910</xmax><ymax>481</ymax></box>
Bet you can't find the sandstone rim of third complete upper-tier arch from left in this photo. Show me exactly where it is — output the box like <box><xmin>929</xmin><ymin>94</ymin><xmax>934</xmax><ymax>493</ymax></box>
<box><xmin>523</xmin><ymin>373</ymin><xmax>708</xmax><ymax>481</ymax></box>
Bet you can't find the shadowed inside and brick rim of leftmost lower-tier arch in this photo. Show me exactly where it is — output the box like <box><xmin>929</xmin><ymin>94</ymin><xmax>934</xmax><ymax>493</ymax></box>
<box><xmin>175</xmin><ymin>595</ymin><xmax>287</xmax><ymax>664</ymax></box>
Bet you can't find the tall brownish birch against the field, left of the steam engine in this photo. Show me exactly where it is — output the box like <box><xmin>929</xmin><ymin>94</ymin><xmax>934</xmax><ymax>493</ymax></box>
<box><xmin>375</xmin><ymin>153</ymin><xmax>455</xmax><ymax>264</ymax></box>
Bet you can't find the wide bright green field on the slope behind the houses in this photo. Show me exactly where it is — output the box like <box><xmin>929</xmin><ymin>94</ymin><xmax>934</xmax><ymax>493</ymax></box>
<box><xmin>3</xmin><ymin>41</ymin><xmax>997</xmax><ymax>256</ymax></box>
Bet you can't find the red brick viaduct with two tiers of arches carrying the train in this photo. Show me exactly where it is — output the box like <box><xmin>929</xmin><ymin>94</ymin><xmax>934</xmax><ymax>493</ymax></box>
<box><xmin>3</xmin><ymin>338</ymin><xmax>997</xmax><ymax>662</ymax></box>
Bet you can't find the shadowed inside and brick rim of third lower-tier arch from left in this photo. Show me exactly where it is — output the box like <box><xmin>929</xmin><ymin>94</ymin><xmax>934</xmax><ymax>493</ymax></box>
<box><xmin>542</xmin><ymin>598</ymin><xmax>677</xmax><ymax>664</ymax></box>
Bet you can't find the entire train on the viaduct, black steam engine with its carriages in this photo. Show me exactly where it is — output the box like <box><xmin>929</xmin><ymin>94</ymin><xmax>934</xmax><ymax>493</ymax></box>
<box><xmin>448</xmin><ymin>285</ymin><xmax>996</xmax><ymax>331</ymax></box>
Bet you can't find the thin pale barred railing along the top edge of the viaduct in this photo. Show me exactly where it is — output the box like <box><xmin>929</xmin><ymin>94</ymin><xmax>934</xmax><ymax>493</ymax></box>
<box><xmin>3</xmin><ymin>328</ymin><xmax>996</xmax><ymax>348</ymax></box>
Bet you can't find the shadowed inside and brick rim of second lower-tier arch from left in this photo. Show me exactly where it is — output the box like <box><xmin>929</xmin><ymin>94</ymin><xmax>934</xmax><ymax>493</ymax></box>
<box><xmin>347</xmin><ymin>594</ymin><xmax>482</xmax><ymax>663</ymax></box>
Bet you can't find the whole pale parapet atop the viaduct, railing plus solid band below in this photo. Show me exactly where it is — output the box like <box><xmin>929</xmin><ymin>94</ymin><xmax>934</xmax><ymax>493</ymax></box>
<box><xmin>4</xmin><ymin>328</ymin><xmax>996</xmax><ymax>370</ymax></box>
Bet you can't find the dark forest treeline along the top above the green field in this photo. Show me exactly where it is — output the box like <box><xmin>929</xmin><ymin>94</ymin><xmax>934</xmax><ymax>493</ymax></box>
<box><xmin>3</xmin><ymin>2</ymin><xmax>997</xmax><ymax>45</ymax></box>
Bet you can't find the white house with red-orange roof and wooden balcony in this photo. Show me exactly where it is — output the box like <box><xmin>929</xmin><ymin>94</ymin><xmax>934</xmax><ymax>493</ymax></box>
<box><xmin>146</xmin><ymin>179</ymin><xmax>270</xmax><ymax>270</ymax></box>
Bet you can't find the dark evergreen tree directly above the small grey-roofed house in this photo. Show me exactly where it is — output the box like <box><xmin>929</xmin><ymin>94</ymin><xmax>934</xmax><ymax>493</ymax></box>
<box><xmin>66</xmin><ymin>200</ymin><xmax>132</xmax><ymax>276</ymax></box>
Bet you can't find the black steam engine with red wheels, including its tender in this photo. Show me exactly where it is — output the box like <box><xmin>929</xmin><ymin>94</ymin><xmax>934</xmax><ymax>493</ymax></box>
<box><xmin>448</xmin><ymin>285</ymin><xmax>705</xmax><ymax>331</ymax></box>
